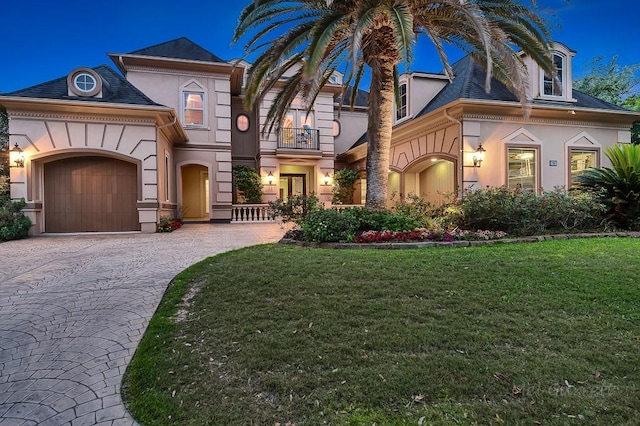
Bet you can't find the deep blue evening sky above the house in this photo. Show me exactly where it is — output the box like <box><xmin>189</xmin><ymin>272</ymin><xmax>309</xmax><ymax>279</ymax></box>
<box><xmin>0</xmin><ymin>0</ymin><xmax>640</xmax><ymax>93</ymax></box>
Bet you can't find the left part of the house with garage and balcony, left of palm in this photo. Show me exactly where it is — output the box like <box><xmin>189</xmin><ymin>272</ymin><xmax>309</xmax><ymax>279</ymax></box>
<box><xmin>0</xmin><ymin>38</ymin><xmax>366</xmax><ymax>233</ymax></box>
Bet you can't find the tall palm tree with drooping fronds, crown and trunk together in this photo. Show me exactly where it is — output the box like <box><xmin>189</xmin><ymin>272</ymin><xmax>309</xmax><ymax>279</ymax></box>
<box><xmin>234</xmin><ymin>0</ymin><xmax>553</xmax><ymax>210</ymax></box>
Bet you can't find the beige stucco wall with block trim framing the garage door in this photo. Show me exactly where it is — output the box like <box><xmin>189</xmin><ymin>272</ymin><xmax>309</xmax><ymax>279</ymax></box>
<box><xmin>8</xmin><ymin>110</ymin><xmax>158</xmax><ymax>233</ymax></box>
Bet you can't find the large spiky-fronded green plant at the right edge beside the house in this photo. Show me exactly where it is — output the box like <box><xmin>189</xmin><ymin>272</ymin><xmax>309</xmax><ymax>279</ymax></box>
<box><xmin>576</xmin><ymin>144</ymin><xmax>640</xmax><ymax>228</ymax></box>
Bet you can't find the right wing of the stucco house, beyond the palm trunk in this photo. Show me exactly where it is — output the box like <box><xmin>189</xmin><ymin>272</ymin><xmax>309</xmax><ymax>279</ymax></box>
<box><xmin>338</xmin><ymin>43</ymin><xmax>640</xmax><ymax>204</ymax></box>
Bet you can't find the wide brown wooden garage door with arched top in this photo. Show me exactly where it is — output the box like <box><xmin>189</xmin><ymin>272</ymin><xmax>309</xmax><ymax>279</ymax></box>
<box><xmin>44</xmin><ymin>157</ymin><xmax>140</xmax><ymax>232</ymax></box>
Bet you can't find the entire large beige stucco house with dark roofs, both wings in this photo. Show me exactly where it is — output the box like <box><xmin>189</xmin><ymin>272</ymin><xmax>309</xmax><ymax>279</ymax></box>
<box><xmin>0</xmin><ymin>38</ymin><xmax>640</xmax><ymax>233</ymax></box>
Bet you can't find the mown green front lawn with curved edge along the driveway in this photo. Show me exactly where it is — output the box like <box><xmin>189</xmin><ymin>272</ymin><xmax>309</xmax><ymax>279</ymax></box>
<box><xmin>123</xmin><ymin>238</ymin><xmax>640</xmax><ymax>426</ymax></box>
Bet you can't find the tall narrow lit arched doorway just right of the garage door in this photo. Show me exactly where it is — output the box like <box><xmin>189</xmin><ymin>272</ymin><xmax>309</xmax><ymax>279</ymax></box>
<box><xmin>180</xmin><ymin>164</ymin><xmax>211</xmax><ymax>221</ymax></box>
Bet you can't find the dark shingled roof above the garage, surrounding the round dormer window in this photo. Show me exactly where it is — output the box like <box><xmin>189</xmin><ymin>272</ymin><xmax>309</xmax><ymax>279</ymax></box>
<box><xmin>3</xmin><ymin>65</ymin><xmax>160</xmax><ymax>106</ymax></box>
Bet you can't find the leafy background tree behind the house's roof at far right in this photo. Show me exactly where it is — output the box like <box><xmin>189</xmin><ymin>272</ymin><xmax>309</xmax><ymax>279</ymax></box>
<box><xmin>573</xmin><ymin>55</ymin><xmax>640</xmax><ymax>144</ymax></box>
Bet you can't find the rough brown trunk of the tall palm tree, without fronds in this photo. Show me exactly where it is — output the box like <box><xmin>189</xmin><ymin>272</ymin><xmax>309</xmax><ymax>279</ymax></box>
<box><xmin>365</xmin><ymin>57</ymin><xmax>395</xmax><ymax>210</ymax></box>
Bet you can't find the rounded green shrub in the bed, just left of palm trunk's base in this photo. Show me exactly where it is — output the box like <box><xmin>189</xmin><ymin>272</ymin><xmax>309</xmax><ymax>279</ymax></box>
<box><xmin>301</xmin><ymin>209</ymin><xmax>358</xmax><ymax>243</ymax></box>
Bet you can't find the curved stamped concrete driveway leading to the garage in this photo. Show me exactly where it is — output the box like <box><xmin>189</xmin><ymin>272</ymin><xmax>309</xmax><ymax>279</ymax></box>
<box><xmin>0</xmin><ymin>224</ymin><xmax>283</xmax><ymax>426</ymax></box>
